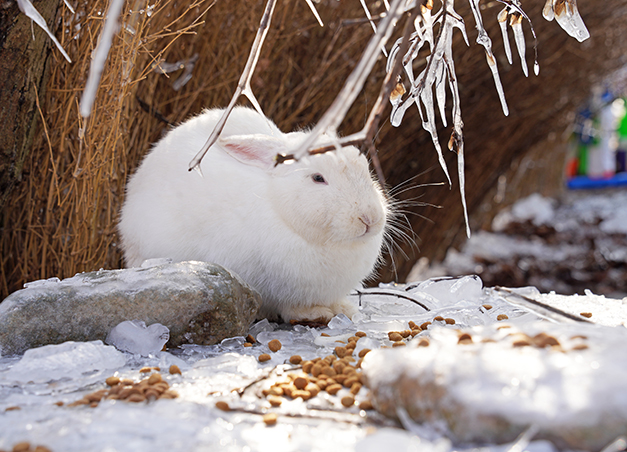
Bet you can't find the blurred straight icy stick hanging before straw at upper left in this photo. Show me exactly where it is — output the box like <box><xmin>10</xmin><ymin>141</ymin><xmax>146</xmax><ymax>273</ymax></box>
<box><xmin>80</xmin><ymin>0</ymin><xmax>124</xmax><ymax>118</ymax></box>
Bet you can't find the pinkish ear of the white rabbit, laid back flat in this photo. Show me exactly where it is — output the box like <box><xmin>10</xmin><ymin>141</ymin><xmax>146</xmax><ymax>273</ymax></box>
<box><xmin>218</xmin><ymin>134</ymin><xmax>286</xmax><ymax>171</ymax></box>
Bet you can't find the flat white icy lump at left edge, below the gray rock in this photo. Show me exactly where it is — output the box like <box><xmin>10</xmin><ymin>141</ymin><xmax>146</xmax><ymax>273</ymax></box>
<box><xmin>2</xmin><ymin>341</ymin><xmax>126</xmax><ymax>384</ymax></box>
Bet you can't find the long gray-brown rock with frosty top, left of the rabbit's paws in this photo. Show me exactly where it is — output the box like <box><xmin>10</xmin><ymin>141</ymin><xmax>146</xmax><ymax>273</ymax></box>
<box><xmin>0</xmin><ymin>262</ymin><xmax>261</xmax><ymax>355</ymax></box>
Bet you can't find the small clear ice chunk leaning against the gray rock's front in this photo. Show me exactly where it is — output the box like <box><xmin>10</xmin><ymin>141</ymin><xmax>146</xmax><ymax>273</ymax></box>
<box><xmin>105</xmin><ymin>320</ymin><xmax>170</xmax><ymax>356</ymax></box>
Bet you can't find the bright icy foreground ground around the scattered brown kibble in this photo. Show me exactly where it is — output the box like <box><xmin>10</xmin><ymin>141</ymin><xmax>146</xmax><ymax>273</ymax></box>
<box><xmin>0</xmin><ymin>277</ymin><xmax>627</xmax><ymax>452</ymax></box>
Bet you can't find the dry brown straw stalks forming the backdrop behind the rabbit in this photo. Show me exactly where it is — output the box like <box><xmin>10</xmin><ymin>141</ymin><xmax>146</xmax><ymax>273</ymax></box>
<box><xmin>0</xmin><ymin>0</ymin><xmax>627</xmax><ymax>295</ymax></box>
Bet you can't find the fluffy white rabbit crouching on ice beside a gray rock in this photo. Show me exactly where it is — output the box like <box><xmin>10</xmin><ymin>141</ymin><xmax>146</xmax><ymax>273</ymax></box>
<box><xmin>119</xmin><ymin>107</ymin><xmax>388</xmax><ymax>322</ymax></box>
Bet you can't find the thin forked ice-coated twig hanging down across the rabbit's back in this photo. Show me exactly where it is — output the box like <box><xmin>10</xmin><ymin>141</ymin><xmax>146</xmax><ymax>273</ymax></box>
<box><xmin>189</xmin><ymin>0</ymin><xmax>276</xmax><ymax>171</ymax></box>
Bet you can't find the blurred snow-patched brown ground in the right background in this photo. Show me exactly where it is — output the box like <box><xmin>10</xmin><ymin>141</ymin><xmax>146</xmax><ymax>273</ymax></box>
<box><xmin>410</xmin><ymin>188</ymin><xmax>627</xmax><ymax>298</ymax></box>
